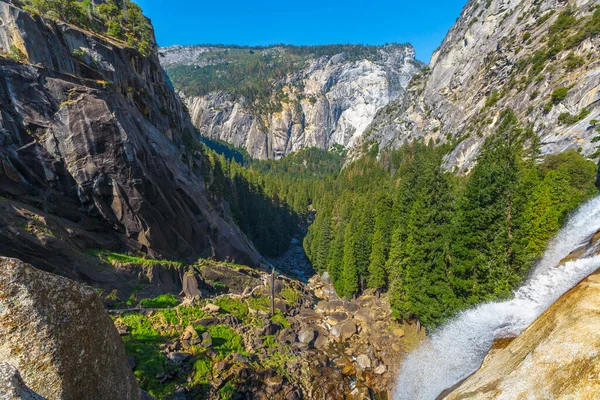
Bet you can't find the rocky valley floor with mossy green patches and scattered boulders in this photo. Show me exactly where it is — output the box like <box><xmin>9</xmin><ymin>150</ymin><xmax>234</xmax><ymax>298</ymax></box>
<box><xmin>113</xmin><ymin>262</ymin><xmax>424</xmax><ymax>400</ymax></box>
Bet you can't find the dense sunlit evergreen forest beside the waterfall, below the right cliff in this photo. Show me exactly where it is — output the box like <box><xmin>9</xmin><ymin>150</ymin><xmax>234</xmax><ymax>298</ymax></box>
<box><xmin>304</xmin><ymin>111</ymin><xmax>596</xmax><ymax>327</ymax></box>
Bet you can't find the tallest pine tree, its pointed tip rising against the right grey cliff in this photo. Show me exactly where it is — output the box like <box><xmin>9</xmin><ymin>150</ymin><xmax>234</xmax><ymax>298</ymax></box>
<box><xmin>453</xmin><ymin>110</ymin><xmax>523</xmax><ymax>302</ymax></box>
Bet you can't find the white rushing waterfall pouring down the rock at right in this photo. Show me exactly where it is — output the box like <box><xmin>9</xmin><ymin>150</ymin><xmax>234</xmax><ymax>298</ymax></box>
<box><xmin>394</xmin><ymin>196</ymin><xmax>600</xmax><ymax>400</ymax></box>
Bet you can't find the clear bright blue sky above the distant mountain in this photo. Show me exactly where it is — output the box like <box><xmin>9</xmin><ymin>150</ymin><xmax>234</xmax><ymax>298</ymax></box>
<box><xmin>136</xmin><ymin>0</ymin><xmax>466</xmax><ymax>62</ymax></box>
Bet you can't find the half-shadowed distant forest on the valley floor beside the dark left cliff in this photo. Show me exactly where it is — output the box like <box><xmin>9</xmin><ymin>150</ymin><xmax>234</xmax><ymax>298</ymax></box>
<box><xmin>203</xmin><ymin>139</ymin><xmax>345</xmax><ymax>257</ymax></box>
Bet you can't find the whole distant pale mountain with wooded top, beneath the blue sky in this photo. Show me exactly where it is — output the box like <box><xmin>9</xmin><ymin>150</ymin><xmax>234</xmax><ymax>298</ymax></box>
<box><xmin>160</xmin><ymin>44</ymin><xmax>422</xmax><ymax>159</ymax></box>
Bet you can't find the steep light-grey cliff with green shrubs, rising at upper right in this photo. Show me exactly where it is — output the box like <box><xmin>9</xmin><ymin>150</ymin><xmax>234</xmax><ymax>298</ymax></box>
<box><xmin>363</xmin><ymin>0</ymin><xmax>600</xmax><ymax>171</ymax></box>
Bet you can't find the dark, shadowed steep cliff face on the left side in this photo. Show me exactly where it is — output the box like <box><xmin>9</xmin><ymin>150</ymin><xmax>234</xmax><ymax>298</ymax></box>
<box><xmin>0</xmin><ymin>2</ymin><xmax>259</xmax><ymax>280</ymax></box>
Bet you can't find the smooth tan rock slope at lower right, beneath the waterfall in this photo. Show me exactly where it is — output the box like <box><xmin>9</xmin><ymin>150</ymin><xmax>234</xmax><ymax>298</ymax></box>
<box><xmin>446</xmin><ymin>271</ymin><xmax>600</xmax><ymax>399</ymax></box>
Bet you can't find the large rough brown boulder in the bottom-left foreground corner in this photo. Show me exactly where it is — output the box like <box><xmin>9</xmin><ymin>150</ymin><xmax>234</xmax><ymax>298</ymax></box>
<box><xmin>0</xmin><ymin>257</ymin><xmax>140</xmax><ymax>400</ymax></box>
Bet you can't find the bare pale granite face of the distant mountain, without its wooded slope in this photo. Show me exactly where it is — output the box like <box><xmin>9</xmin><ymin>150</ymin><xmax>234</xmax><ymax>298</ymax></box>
<box><xmin>161</xmin><ymin>45</ymin><xmax>421</xmax><ymax>159</ymax></box>
